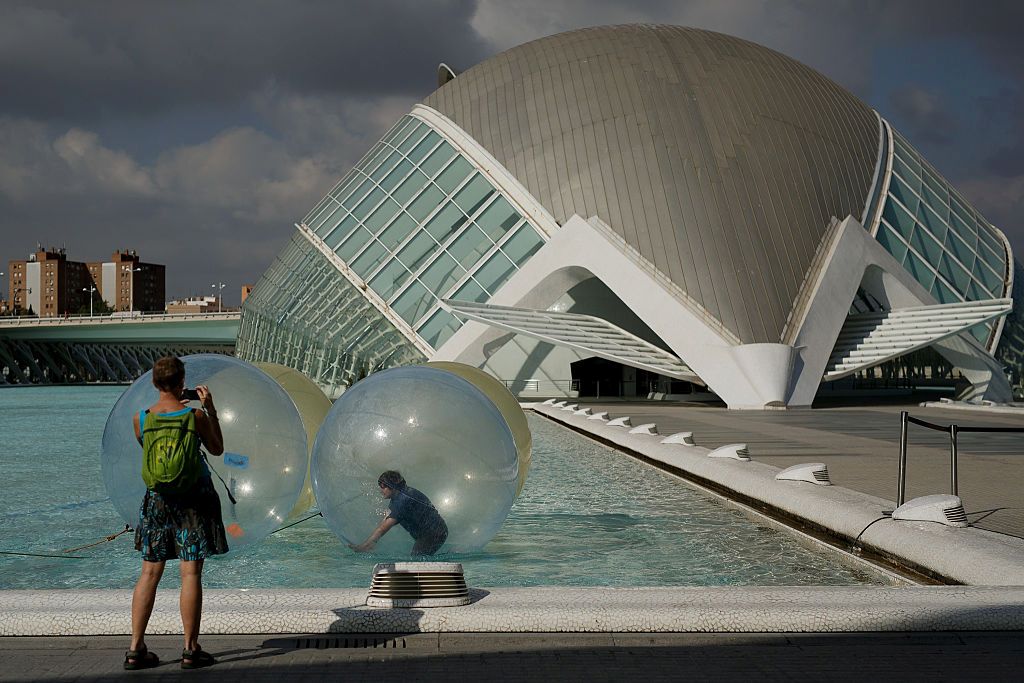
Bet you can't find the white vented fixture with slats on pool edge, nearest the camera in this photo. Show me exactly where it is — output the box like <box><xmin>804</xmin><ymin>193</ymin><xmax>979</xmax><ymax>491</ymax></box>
<box><xmin>367</xmin><ymin>562</ymin><xmax>469</xmax><ymax>607</ymax></box>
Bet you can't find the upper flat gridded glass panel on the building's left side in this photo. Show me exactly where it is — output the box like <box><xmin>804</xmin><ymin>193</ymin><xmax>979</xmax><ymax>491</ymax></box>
<box><xmin>303</xmin><ymin>116</ymin><xmax>544</xmax><ymax>348</ymax></box>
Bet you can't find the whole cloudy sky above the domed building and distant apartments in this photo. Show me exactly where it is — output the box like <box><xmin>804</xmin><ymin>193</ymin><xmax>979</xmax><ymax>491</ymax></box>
<box><xmin>0</xmin><ymin>0</ymin><xmax>1024</xmax><ymax>303</ymax></box>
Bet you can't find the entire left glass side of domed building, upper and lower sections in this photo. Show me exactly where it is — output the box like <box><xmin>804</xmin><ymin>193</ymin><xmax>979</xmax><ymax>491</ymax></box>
<box><xmin>238</xmin><ymin>116</ymin><xmax>544</xmax><ymax>387</ymax></box>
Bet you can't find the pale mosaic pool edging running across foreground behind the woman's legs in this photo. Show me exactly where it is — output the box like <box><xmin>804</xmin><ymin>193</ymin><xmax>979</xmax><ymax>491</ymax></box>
<box><xmin>0</xmin><ymin>586</ymin><xmax>1024</xmax><ymax>636</ymax></box>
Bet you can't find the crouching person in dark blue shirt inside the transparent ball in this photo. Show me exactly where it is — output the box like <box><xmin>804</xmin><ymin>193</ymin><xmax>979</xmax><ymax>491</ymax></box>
<box><xmin>348</xmin><ymin>470</ymin><xmax>447</xmax><ymax>557</ymax></box>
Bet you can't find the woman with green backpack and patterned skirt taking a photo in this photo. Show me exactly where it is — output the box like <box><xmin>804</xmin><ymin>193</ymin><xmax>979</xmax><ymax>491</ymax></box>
<box><xmin>124</xmin><ymin>356</ymin><xmax>227</xmax><ymax>670</ymax></box>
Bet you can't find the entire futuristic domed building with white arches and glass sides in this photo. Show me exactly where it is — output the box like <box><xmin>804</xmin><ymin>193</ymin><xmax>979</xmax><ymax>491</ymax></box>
<box><xmin>237</xmin><ymin>26</ymin><xmax>1024</xmax><ymax>409</ymax></box>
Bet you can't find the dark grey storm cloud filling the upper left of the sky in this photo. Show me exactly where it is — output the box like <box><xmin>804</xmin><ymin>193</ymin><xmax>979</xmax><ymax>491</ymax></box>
<box><xmin>0</xmin><ymin>0</ymin><xmax>484</xmax><ymax>119</ymax></box>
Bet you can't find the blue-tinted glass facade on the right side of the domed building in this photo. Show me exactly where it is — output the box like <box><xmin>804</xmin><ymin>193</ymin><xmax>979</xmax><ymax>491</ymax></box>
<box><xmin>876</xmin><ymin>130</ymin><xmax>1009</xmax><ymax>350</ymax></box>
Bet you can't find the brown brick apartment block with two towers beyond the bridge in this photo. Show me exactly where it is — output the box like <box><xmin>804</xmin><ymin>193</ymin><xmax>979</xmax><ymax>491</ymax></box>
<box><xmin>8</xmin><ymin>247</ymin><xmax>165</xmax><ymax>317</ymax></box>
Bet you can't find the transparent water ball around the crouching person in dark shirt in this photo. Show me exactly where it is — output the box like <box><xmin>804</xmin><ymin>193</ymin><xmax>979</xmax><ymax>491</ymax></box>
<box><xmin>311</xmin><ymin>366</ymin><xmax>518</xmax><ymax>556</ymax></box>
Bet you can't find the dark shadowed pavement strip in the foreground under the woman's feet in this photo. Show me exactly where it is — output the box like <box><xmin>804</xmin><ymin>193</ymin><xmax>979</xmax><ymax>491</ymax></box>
<box><xmin>0</xmin><ymin>632</ymin><xmax>1024</xmax><ymax>683</ymax></box>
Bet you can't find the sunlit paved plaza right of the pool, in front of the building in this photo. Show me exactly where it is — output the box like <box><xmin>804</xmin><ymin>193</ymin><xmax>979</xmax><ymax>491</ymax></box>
<box><xmin>581</xmin><ymin>400</ymin><xmax>1024</xmax><ymax>538</ymax></box>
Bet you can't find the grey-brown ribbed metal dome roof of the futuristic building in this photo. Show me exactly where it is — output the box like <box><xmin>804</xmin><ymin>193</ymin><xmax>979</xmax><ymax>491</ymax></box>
<box><xmin>424</xmin><ymin>26</ymin><xmax>880</xmax><ymax>343</ymax></box>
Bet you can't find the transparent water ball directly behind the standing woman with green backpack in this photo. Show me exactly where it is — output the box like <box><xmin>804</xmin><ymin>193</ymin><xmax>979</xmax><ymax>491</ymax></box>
<box><xmin>101</xmin><ymin>353</ymin><xmax>307</xmax><ymax>550</ymax></box>
